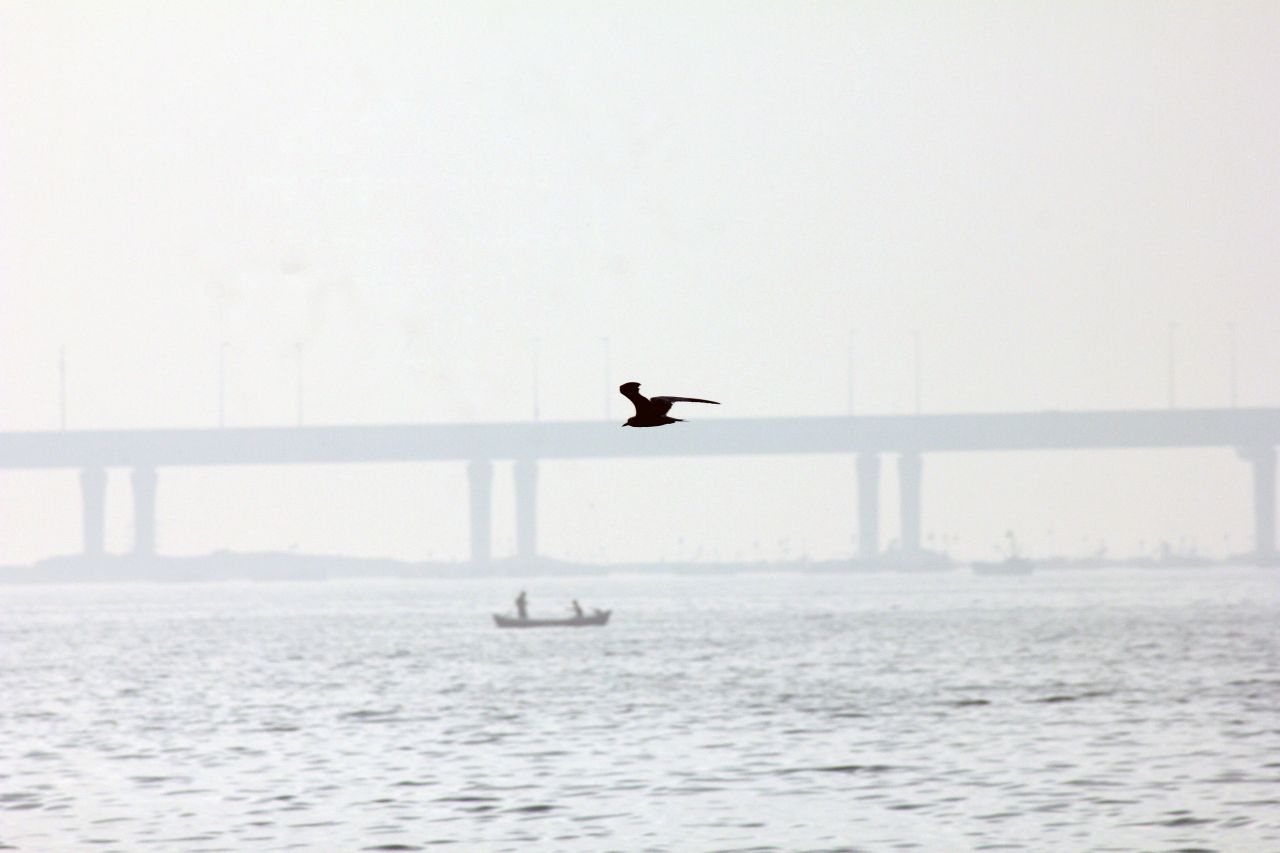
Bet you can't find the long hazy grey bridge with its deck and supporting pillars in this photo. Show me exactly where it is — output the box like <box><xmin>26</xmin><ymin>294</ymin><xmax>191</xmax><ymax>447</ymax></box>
<box><xmin>0</xmin><ymin>409</ymin><xmax>1280</xmax><ymax>561</ymax></box>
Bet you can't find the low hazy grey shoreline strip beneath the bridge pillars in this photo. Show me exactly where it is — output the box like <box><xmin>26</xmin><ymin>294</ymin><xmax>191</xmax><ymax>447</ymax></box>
<box><xmin>0</xmin><ymin>551</ymin><xmax>1257</xmax><ymax>584</ymax></box>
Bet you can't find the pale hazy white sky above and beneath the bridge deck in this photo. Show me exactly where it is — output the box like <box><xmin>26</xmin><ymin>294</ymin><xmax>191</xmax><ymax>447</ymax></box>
<box><xmin>0</xmin><ymin>1</ymin><xmax>1280</xmax><ymax>561</ymax></box>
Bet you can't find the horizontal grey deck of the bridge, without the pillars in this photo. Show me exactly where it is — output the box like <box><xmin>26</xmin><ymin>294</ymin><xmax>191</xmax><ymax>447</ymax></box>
<box><xmin>0</xmin><ymin>409</ymin><xmax>1280</xmax><ymax>467</ymax></box>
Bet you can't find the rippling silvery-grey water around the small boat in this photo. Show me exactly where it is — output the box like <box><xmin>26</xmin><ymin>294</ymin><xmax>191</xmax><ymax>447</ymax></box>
<box><xmin>0</xmin><ymin>560</ymin><xmax>1280</xmax><ymax>853</ymax></box>
